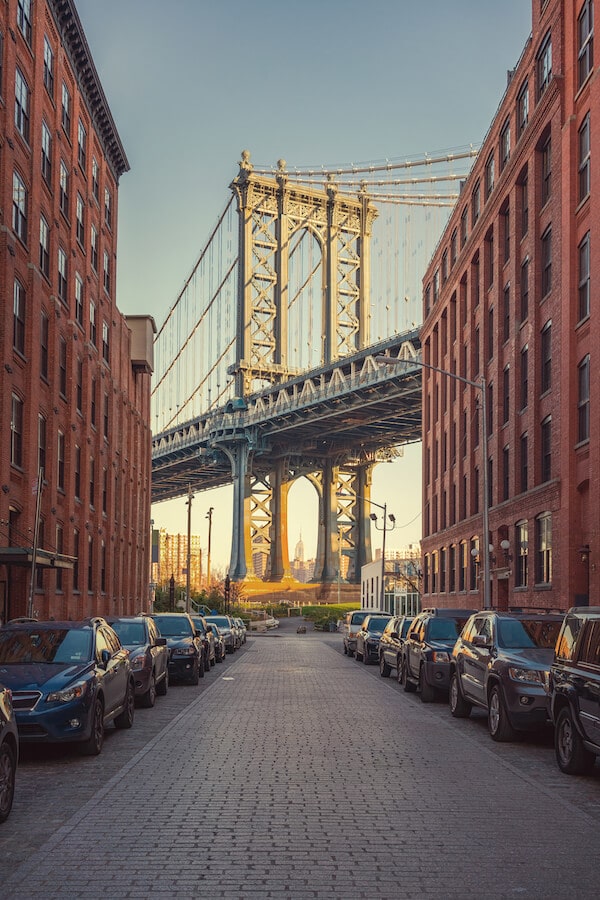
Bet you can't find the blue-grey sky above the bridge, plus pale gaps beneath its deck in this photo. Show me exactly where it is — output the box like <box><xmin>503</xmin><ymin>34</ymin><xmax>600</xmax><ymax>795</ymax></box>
<box><xmin>76</xmin><ymin>0</ymin><xmax>531</xmax><ymax>570</ymax></box>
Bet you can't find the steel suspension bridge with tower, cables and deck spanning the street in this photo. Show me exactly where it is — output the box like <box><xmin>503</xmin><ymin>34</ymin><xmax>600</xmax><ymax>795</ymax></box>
<box><xmin>152</xmin><ymin>147</ymin><xmax>477</xmax><ymax>585</ymax></box>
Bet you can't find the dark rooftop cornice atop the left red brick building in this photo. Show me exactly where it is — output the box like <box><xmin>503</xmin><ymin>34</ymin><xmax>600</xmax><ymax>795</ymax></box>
<box><xmin>48</xmin><ymin>0</ymin><xmax>129</xmax><ymax>181</ymax></box>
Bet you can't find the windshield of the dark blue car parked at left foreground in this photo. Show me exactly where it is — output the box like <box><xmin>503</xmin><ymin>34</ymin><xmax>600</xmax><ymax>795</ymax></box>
<box><xmin>0</xmin><ymin>628</ymin><xmax>92</xmax><ymax>665</ymax></box>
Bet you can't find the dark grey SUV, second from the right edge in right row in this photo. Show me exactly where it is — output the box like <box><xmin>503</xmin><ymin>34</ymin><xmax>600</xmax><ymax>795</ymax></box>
<box><xmin>449</xmin><ymin>610</ymin><xmax>563</xmax><ymax>741</ymax></box>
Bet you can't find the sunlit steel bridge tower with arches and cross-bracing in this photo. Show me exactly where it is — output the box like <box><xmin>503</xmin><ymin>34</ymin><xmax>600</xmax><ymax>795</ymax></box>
<box><xmin>220</xmin><ymin>151</ymin><xmax>377</xmax><ymax>582</ymax></box>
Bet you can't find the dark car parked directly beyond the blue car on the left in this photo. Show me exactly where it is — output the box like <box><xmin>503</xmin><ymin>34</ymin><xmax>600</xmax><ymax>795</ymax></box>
<box><xmin>107</xmin><ymin>615</ymin><xmax>169</xmax><ymax>708</ymax></box>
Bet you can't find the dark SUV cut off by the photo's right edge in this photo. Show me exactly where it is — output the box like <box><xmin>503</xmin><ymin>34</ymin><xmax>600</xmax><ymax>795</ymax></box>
<box><xmin>550</xmin><ymin>606</ymin><xmax>600</xmax><ymax>775</ymax></box>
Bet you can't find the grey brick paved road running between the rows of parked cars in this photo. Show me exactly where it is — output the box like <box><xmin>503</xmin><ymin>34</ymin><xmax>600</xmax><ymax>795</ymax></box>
<box><xmin>0</xmin><ymin>633</ymin><xmax>600</xmax><ymax>900</ymax></box>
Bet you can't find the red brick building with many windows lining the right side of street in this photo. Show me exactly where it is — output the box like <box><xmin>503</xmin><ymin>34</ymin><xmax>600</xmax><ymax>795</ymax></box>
<box><xmin>421</xmin><ymin>0</ymin><xmax>600</xmax><ymax>609</ymax></box>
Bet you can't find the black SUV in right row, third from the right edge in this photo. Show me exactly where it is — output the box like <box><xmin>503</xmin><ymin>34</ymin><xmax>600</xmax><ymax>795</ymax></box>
<box><xmin>400</xmin><ymin>609</ymin><xmax>475</xmax><ymax>703</ymax></box>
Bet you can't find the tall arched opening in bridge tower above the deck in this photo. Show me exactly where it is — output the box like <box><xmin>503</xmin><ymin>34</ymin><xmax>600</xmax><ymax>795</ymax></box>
<box><xmin>287</xmin><ymin>228</ymin><xmax>324</xmax><ymax>369</ymax></box>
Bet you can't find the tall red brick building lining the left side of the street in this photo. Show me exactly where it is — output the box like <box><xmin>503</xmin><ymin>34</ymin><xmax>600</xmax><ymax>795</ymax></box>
<box><xmin>0</xmin><ymin>0</ymin><xmax>154</xmax><ymax>619</ymax></box>
